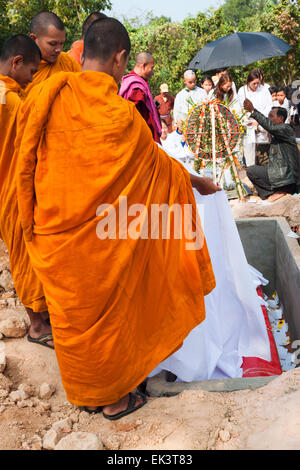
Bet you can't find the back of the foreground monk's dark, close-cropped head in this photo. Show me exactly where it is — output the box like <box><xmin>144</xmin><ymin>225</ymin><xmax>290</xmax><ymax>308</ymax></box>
<box><xmin>83</xmin><ymin>17</ymin><xmax>131</xmax><ymax>62</ymax></box>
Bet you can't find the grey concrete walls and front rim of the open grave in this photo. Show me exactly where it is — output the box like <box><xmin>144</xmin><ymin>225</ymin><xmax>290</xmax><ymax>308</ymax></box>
<box><xmin>147</xmin><ymin>217</ymin><xmax>300</xmax><ymax>397</ymax></box>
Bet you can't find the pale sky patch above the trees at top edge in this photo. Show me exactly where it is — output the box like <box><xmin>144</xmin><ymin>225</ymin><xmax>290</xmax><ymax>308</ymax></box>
<box><xmin>104</xmin><ymin>0</ymin><xmax>223</xmax><ymax>22</ymax></box>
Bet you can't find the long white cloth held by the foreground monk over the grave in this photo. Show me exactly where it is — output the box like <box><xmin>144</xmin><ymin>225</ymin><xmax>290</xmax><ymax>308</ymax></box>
<box><xmin>150</xmin><ymin>151</ymin><xmax>271</xmax><ymax>382</ymax></box>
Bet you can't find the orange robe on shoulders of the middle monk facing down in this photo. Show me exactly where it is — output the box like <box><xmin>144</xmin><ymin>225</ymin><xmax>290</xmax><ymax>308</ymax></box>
<box><xmin>25</xmin><ymin>52</ymin><xmax>81</xmax><ymax>94</ymax></box>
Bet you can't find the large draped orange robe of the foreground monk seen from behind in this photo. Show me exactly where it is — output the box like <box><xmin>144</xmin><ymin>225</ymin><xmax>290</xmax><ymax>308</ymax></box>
<box><xmin>18</xmin><ymin>71</ymin><xmax>215</xmax><ymax>406</ymax></box>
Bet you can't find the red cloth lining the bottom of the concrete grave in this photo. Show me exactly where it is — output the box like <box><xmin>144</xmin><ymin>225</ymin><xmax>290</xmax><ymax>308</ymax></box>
<box><xmin>242</xmin><ymin>287</ymin><xmax>282</xmax><ymax>377</ymax></box>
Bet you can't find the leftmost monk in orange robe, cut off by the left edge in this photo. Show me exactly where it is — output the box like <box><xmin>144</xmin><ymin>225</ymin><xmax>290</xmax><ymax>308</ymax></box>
<box><xmin>0</xmin><ymin>34</ymin><xmax>53</xmax><ymax>348</ymax></box>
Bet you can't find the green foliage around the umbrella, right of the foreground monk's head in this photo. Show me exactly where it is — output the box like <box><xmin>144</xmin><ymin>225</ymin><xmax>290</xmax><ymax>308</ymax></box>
<box><xmin>126</xmin><ymin>0</ymin><xmax>300</xmax><ymax>95</ymax></box>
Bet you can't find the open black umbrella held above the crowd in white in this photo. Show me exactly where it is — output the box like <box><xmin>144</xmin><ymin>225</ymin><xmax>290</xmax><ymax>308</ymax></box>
<box><xmin>189</xmin><ymin>33</ymin><xmax>292</xmax><ymax>72</ymax></box>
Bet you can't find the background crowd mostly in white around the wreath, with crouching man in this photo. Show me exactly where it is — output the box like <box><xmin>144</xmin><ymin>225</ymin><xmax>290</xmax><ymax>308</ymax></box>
<box><xmin>155</xmin><ymin>68</ymin><xmax>300</xmax><ymax>202</ymax></box>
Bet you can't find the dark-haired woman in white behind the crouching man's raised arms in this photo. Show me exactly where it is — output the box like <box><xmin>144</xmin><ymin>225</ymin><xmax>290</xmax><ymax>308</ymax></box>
<box><xmin>238</xmin><ymin>69</ymin><xmax>273</xmax><ymax>166</ymax></box>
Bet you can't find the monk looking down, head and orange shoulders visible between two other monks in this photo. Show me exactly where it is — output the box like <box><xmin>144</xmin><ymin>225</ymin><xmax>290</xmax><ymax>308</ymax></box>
<box><xmin>25</xmin><ymin>11</ymin><xmax>81</xmax><ymax>93</ymax></box>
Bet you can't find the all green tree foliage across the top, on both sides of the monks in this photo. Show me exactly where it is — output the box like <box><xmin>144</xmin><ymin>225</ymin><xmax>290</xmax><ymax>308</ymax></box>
<box><xmin>0</xmin><ymin>0</ymin><xmax>300</xmax><ymax>95</ymax></box>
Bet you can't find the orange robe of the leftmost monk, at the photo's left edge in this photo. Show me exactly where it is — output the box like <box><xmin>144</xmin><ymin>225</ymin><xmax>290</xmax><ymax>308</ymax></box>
<box><xmin>0</xmin><ymin>75</ymin><xmax>47</xmax><ymax>312</ymax></box>
